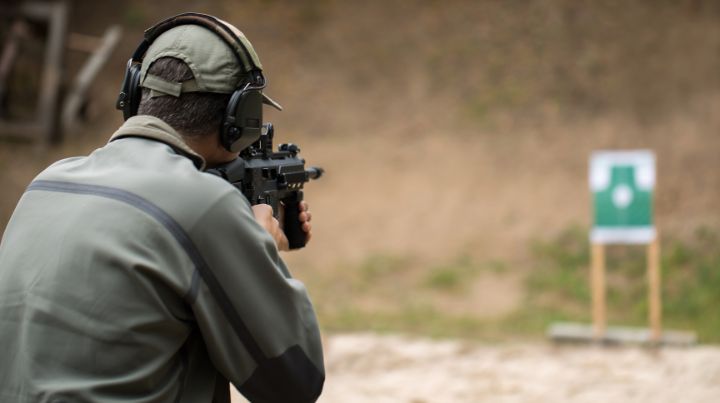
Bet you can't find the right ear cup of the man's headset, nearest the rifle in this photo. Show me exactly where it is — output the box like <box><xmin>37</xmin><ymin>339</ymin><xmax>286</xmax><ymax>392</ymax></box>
<box><xmin>220</xmin><ymin>89</ymin><xmax>262</xmax><ymax>153</ymax></box>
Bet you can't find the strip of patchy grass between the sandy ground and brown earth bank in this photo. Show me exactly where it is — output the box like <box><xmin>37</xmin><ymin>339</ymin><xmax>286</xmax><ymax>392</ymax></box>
<box><xmin>308</xmin><ymin>226</ymin><xmax>720</xmax><ymax>343</ymax></box>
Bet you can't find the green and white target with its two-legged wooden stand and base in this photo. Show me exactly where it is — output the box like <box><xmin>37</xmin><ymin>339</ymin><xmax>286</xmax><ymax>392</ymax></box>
<box><xmin>548</xmin><ymin>150</ymin><xmax>696</xmax><ymax>346</ymax></box>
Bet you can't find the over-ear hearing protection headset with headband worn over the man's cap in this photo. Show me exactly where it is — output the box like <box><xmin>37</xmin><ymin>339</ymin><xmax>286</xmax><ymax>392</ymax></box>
<box><xmin>115</xmin><ymin>13</ymin><xmax>272</xmax><ymax>152</ymax></box>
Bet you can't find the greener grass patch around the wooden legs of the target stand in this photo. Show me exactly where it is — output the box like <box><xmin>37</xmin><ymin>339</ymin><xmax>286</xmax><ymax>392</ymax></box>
<box><xmin>526</xmin><ymin>228</ymin><xmax>720</xmax><ymax>343</ymax></box>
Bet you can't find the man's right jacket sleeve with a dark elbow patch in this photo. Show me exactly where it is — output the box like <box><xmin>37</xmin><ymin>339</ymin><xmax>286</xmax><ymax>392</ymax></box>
<box><xmin>186</xmin><ymin>192</ymin><xmax>325</xmax><ymax>402</ymax></box>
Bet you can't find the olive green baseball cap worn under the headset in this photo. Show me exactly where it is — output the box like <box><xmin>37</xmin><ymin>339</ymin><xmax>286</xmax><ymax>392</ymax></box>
<box><xmin>140</xmin><ymin>20</ymin><xmax>282</xmax><ymax>110</ymax></box>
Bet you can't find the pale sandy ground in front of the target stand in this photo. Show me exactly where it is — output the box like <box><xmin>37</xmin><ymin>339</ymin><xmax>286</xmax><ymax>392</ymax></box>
<box><xmin>233</xmin><ymin>334</ymin><xmax>720</xmax><ymax>403</ymax></box>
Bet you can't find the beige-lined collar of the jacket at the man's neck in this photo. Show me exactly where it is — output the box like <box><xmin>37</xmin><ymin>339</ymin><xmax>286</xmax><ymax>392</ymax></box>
<box><xmin>110</xmin><ymin>115</ymin><xmax>205</xmax><ymax>170</ymax></box>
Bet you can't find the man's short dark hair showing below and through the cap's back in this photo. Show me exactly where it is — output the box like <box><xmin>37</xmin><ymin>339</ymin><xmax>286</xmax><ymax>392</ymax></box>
<box><xmin>138</xmin><ymin>57</ymin><xmax>230</xmax><ymax>137</ymax></box>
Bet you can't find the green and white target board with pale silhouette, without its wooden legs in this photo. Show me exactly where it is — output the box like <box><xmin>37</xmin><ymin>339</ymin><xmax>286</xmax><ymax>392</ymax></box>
<box><xmin>590</xmin><ymin>150</ymin><xmax>656</xmax><ymax>244</ymax></box>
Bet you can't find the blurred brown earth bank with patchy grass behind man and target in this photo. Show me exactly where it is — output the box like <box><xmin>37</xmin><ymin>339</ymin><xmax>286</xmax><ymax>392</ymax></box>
<box><xmin>0</xmin><ymin>0</ymin><xmax>720</xmax><ymax>398</ymax></box>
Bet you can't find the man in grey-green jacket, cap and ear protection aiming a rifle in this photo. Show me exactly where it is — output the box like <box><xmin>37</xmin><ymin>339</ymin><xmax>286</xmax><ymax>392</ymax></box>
<box><xmin>0</xmin><ymin>13</ymin><xmax>325</xmax><ymax>403</ymax></box>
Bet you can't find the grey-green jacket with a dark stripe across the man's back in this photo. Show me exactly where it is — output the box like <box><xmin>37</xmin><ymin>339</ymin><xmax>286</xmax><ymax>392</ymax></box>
<box><xmin>0</xmin><ymin>116</ymin><xmax>324</xmax><ymax>403</ymax></box>
